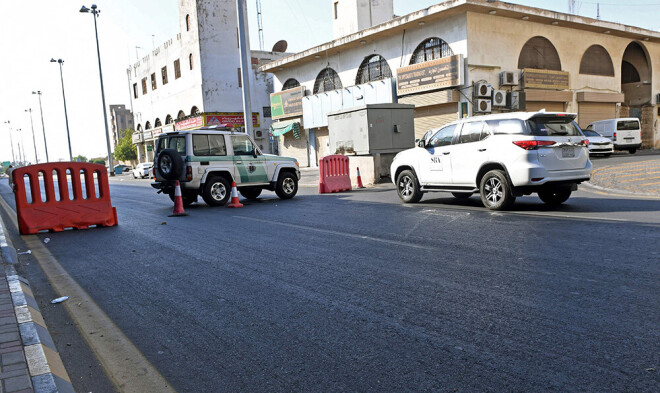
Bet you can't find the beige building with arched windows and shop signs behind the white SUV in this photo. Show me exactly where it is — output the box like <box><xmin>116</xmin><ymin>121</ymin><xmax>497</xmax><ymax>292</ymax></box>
<box><xmin>260</xmin><ymin>0</ymin><xmax>660</xmax><ymax>166</ymax></box>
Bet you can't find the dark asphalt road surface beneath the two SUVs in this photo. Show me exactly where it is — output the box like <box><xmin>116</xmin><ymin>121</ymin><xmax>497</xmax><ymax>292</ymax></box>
<box><xmin>0</xmin><ymin>157</ymin><xmax>660</xmax><ymax>392</ymax></box>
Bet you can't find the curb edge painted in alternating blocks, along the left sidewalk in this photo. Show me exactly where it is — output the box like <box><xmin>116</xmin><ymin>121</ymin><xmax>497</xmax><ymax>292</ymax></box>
<box><xmin>0</xmin><ymin>214</ymin><xmax>75</xmax><ymax>393</ymax></box>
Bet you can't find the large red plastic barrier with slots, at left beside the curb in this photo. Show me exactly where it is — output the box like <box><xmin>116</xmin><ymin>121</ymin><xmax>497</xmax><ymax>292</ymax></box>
<box><xmin>12</xmin><ymin>162</ymin><xmax>117</xmax><ymax>235</ymax></box>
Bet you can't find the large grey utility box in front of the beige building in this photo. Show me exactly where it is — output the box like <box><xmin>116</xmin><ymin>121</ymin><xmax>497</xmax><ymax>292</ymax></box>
<box><xmin>328</xmin><ymin>104</ymin><xmax>415</xmax><ymax>155</ymax></box>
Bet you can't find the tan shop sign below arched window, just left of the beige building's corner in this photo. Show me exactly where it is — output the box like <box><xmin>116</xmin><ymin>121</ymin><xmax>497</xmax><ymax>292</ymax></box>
<box><xmin>396</xmin><ymin>55</ymin><xmax>464</xmax><ymax>96</ymax></box>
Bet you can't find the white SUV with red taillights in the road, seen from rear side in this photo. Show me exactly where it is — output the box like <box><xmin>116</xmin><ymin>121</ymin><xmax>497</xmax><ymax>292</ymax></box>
<box><xmin>390</xmin><ymin>112</ymin><xmax>591</xmax><ymax>210</ymax></box>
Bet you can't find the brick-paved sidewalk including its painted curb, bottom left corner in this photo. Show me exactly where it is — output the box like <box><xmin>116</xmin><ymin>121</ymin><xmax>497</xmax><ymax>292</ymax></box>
<box><xmin>0</xmin><ymin>217</ymin><xmax>75</xmax><ymax>393</ymax></box>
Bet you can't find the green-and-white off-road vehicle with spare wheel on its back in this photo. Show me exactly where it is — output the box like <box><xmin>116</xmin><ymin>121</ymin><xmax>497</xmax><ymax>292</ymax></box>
<box><xmin>151</xmin><ymin>126</ymin><xmax>300</xmax><ymax>206</ymax></box>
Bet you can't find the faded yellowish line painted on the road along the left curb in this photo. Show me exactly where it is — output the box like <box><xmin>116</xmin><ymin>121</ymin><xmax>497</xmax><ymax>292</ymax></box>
<box><xmin>0</xmin><ymin>197</ymin><xmax>176</xmax><ymax>393</ymax></box>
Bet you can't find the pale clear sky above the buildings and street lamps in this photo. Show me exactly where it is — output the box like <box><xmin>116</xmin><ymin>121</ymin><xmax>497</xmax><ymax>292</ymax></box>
<box><xmin>0</xmin><ymin>0</ymin><xmax>660</xmax><ymax>162</ymax></box>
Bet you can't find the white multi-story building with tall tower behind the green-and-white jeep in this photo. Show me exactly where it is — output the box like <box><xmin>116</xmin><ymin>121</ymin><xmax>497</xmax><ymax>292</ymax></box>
<box><xmin>129</xmin><ymin>0</ymin><xmax>284</xmax><ymax>162</ymax></box>
